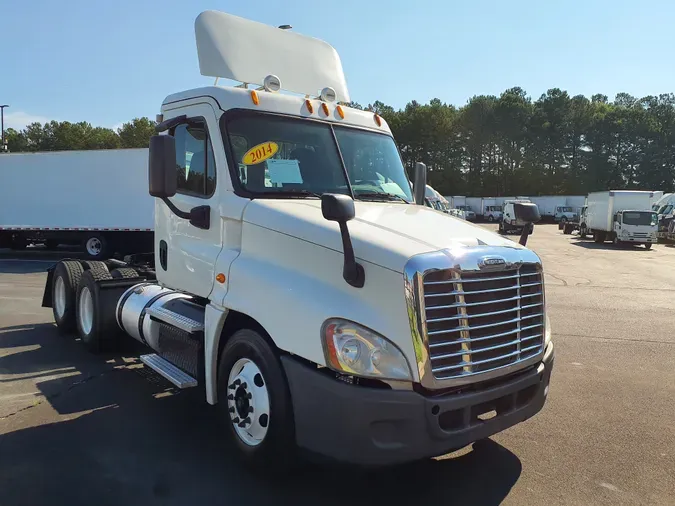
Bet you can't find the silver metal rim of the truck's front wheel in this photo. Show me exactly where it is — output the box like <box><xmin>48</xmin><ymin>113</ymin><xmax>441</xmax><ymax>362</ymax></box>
<box><xmin>227</xmin><ymin>358</ymin><xmax>270</xmax><ymax>446</ymax></box>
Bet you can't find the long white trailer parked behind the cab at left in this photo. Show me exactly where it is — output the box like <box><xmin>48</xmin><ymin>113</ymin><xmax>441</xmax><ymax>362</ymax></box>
<box><xmin>0</xmin><ymin>149</ymin><xmax>155</xmax><ymax>259</ymax></box>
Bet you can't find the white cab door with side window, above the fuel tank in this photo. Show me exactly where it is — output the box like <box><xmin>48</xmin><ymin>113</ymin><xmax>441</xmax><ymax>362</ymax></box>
<box><xmin>155</xmin><ymin>103</ymin><xmax>224</xmax><ymax>297</ymax></box>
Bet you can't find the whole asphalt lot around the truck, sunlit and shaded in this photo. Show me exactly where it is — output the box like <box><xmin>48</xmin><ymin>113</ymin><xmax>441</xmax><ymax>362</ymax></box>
<box><xmin>0</xmin><ymin>225</ymin><xmax>675</xmax><ymax>506</ymax></box>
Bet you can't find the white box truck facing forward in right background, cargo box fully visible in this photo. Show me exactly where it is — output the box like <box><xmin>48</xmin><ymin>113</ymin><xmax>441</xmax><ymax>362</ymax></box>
<box><xmin>586</xmin><ymin>190</ymin><xmax>658</xmax><ymax>249</ymax></box>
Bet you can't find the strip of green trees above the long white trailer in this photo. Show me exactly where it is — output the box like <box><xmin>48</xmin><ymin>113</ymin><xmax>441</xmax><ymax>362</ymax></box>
<box><xmin>5</xmin><ymin>118</ymin><xmax>155</xmax><ymax>153</ymax></box>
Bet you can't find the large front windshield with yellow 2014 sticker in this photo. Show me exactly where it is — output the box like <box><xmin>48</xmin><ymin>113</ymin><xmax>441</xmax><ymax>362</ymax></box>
<box><xmin>227</xmin><ymin>114</ymin><xmax>412</xmax><ymax>202</ymax></box>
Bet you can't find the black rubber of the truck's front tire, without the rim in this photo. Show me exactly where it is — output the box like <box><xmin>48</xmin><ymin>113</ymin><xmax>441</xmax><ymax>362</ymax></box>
<box><xmin>218</xmin><ymin>329</ymin><xmax>297</xmax><ymax>468</ymax></box>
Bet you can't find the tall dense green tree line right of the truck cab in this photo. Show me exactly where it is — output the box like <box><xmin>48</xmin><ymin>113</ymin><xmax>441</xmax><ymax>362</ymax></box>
<box><xmin>352</xmin><ymin>88</ymin><xmax>675</xmax><ymax>196</ymax></box>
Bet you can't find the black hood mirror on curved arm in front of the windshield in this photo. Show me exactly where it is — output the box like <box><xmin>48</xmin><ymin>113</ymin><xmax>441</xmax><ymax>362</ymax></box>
<box><xmin>321</xmin><ymin>193</ymin><xmax>366</xmax><ymax>288</ymax></box>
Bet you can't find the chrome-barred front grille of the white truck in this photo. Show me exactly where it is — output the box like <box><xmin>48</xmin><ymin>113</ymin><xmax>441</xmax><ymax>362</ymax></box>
<box><xmin>423</xmin><ymin>264</ymin><xmax>544</xmax><ymax>380</ymax></box>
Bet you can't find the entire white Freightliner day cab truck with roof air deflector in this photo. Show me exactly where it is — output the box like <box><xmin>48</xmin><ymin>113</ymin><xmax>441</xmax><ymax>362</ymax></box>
<box><xmin>43</xmin><ymin>11</ymin><xmax>553</xmax><ymax>466</ymax></box>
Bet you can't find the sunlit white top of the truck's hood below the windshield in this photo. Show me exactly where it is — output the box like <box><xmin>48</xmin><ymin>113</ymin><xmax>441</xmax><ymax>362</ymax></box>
<box><xmin>243</xmin><ymin>199</ymin><xmax>522</xmax><ymax>272</ymax></box>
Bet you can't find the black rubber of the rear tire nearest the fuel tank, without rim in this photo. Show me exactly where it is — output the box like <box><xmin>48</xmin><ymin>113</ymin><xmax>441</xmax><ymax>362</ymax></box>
<box><xmin>75</xmin><ymin>269</ymin><xmax>120</xmax><ymax>353</ymax></box>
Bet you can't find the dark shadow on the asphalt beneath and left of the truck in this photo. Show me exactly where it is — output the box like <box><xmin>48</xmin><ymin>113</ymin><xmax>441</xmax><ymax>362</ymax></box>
<box><xmin>0</xmin><ymin>324</ymin><xmax>521</xmax><ymax>506</ymax></box>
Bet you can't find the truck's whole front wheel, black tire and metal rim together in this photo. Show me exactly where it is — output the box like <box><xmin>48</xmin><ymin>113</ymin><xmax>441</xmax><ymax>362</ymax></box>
<box><xmin>218</xmin><ymin>329</ymin><xmax>296</xmax><ymax>467</ymax></box>
